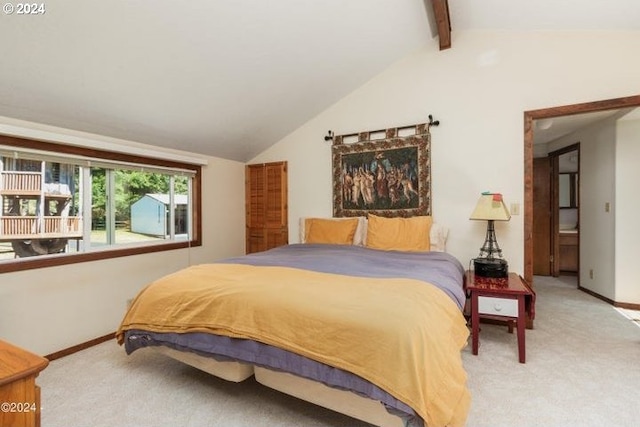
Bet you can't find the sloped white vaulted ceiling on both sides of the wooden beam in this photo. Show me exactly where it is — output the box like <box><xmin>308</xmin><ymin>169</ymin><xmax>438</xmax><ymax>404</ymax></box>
<box><xmin>0</xmin><ymin>0</ymin><xmax>640</xmax><ymax>161</ymax></box>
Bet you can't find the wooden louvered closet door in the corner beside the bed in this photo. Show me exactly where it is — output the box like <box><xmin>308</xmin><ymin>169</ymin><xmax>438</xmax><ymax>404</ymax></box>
<box><xmin>245</xmin><ymin>162</ymin><xmax>289</xmax><ymax>253</ymax></box>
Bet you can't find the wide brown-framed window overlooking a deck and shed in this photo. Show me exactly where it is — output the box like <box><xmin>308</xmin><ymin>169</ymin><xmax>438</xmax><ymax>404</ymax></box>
<box><xmin>0</xmin><ymin>136</ymin><xmax>201</xmax><ymax>273</ymax></box>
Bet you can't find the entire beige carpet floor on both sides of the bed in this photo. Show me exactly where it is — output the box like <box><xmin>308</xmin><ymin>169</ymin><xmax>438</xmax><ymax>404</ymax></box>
<box><xmin>38</xmin><ymin>277</ymin><xmax>640</xmax><ymax>427</ymax></box>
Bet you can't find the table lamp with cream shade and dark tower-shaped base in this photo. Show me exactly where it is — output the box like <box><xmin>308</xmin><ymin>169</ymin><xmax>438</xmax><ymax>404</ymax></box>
<box><xmin>469</xmin><ymin>192</ymin><xmax>511</xmax><ymax>278</ymax></box>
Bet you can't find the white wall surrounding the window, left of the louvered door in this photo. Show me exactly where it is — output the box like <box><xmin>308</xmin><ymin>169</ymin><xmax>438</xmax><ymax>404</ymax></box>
<box><xmin>0</xmin><ymin>125</ymin><xmax>244</xmax><ymax>355</ymax></box>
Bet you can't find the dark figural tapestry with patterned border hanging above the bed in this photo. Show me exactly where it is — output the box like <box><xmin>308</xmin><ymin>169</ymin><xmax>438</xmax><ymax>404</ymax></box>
<box><xmin>332</xmin><ymin>123</ymin><xmax>431</xmax><ymax>217</ymax></box>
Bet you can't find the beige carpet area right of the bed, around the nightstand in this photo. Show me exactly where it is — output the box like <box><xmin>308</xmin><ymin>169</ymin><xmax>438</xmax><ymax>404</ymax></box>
<box><xmin>464</xmin><ymin>277</ymin><xmax>640</xmax><ymax>427</ymax></box>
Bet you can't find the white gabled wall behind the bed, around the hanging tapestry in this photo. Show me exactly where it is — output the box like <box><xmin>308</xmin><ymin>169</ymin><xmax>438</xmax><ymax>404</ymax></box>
<box><xmin>252</xmin><ymin>31</ymin><xmax>640</xmax><ymax>290</ymax></box>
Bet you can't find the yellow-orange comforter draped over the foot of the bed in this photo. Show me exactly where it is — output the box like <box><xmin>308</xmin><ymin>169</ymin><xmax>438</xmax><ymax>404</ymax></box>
<box><xmin>116</xmin><ymin>264</ymin><xmax>470</xmax><ymax>427</ymax></box>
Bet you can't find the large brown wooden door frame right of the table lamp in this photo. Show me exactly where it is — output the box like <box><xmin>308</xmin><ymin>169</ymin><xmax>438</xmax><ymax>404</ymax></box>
<box><xmin>523</xmin><ymin>95</ymin><xmax>640</xmax><ymax>284</ymax></box>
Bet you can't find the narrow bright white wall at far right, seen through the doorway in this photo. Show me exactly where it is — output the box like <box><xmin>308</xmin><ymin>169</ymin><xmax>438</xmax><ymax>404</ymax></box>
<box><xmin>614</xmin><ymin>110</ymin><xmax>640</xmax><ymax>304</ymax></box>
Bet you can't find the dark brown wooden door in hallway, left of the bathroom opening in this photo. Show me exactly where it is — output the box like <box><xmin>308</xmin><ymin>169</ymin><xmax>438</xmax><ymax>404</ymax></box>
<box><xmin>533</xmin><ymin>157</ymin><xmax>553</xmax><ymax>276</ymax></box>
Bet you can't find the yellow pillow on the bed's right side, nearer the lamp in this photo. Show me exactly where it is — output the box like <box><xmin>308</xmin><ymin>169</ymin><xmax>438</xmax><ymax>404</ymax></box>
<box><xmin>367</xmin><ymin>214</ymin><xmax>433</xmax><ymax>252</ymax></box>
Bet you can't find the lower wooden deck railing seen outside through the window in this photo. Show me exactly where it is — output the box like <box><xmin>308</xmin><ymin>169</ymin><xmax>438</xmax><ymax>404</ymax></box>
<box><xmin>0</xmin><ymin>216</ymin><xmax>82</xmax><ymax>241</ymax></box>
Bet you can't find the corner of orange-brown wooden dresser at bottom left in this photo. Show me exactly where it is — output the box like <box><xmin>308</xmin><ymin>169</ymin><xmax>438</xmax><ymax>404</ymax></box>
<box><xmin>0</xmin><ymin>341</ymin><xmax>49</xmax><ymax>427</ymax></box>
